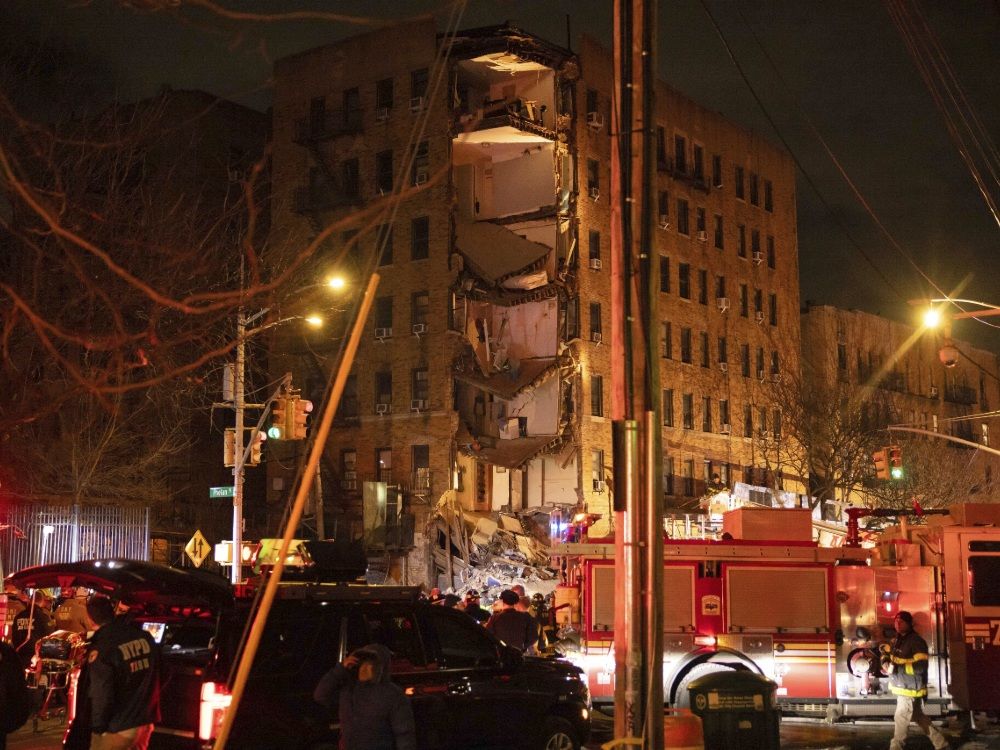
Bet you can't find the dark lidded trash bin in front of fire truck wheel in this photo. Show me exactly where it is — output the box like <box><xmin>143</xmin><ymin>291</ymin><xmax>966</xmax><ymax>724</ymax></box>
<box><xmin>688</xmin><ymin>670</ymin><xmax>781</xmax><ymax>750</ymax></box>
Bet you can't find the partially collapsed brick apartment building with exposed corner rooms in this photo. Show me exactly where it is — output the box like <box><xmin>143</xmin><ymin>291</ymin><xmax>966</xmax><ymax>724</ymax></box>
<box><xmin>269</xmin><ymin>20</ymin><xmax>799</xmax><ymax>580</ymax></box>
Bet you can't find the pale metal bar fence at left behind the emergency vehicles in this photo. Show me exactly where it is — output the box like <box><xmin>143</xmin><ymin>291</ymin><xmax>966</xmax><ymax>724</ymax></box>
<box><xmin>0</xmin><ymin>505</ymin><xmax>149</xmax><ymax>574</ymax></box>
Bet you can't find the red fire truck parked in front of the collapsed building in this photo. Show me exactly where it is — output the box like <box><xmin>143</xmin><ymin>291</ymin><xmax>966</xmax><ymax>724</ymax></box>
<box><xmin>553</xmin><ymin>504</ymin><xmax>1000</xmax><ymax>720</ymax></box>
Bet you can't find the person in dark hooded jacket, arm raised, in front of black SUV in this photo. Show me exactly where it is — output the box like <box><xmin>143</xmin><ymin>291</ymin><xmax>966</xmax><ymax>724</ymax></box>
<box><xmin>313</xmin><ymin>643</ymin><xmax>417</xmax><ymax>750</ymax></box>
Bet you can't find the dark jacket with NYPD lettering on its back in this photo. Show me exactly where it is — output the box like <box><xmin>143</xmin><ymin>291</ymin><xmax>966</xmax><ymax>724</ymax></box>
<box><xmin>87</xmin><ymin>618</ymin><xmax>160</xmax><ymax>734</ymax></box>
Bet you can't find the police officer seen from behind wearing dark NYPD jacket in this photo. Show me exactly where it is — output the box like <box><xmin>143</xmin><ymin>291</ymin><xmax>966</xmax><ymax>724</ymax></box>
<box><xmin>86</xmin><ymin>597</ymin><xmax>160</xmax><ymax>750</ymax></box>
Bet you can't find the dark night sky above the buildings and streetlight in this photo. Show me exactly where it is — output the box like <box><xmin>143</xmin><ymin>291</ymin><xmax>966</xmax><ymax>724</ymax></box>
<box><xmin>7</xmin><ymin>0</ymin><xmax>1000</xmax><ymax>352</ymax></box>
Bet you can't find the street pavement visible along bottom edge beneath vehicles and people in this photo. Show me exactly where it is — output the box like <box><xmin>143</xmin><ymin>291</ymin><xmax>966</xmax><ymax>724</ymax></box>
<box><xmin>7</xmin><ymin>712</ymin><xmax>1000</xmax><ymax>750</ymax></box>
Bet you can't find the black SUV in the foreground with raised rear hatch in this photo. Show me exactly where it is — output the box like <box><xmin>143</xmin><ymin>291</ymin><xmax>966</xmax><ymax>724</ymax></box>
<box><xmin>10</xmin><ymin>560</ymin><xmax>590</xmax><ymax>750</ymax></box>
